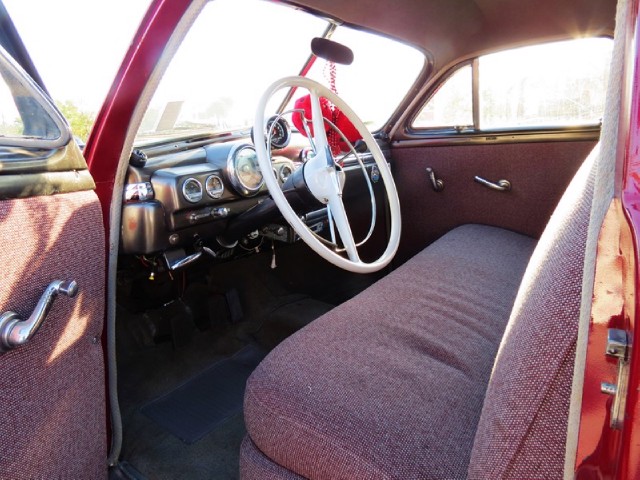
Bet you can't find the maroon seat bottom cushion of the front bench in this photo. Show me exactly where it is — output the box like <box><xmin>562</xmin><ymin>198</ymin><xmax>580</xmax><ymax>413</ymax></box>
<box><xmin>245</xmin><ymin>225</ymin><xmax>535</xmax><ymax>479</ymax></box>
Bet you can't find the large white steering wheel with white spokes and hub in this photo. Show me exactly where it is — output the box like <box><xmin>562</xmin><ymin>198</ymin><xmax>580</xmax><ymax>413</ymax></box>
<box><xmin>253</xmin><ymin>77</ymin><xmax>400</xmax><ymax>273</ymax></box>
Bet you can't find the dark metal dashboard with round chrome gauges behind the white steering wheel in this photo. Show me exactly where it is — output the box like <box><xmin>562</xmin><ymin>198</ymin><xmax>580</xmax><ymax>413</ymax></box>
<box><xmin>120</xmin><ymin>125</ymin><xmax>390</xmax><ymax>268</ymax></box>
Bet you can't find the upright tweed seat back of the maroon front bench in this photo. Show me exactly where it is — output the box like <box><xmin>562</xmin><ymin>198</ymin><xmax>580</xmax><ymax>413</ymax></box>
<box><xmin>468</xmin><ymin>147</ymin><xmax>598</xmax><ymax>479</ymax></box>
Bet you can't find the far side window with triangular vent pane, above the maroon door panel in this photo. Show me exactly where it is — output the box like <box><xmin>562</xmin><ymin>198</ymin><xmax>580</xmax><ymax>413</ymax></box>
<box><xmin>412</xmin><ymin>38</ymin><xmax>613</xmax><ymax>130</ymax></box>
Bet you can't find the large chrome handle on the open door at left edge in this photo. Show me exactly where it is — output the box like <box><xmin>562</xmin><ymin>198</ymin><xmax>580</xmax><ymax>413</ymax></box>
<box><xmin>0</xmin><ymin>280</ymin><xmax>78</xmax><ymax>354</ymax></box>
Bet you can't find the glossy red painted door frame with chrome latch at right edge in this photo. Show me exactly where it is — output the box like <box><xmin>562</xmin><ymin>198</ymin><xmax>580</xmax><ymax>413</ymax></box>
<box><xmin>576</xmin><ymin>0</ymin><xmax>640</xmax><ymax>480</ymax></box>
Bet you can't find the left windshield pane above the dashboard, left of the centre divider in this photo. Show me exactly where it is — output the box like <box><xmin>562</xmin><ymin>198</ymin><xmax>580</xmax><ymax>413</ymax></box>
<box><xmin>138</xmin><ymin>0</ymin><xmax>326</xmax><ymax>141</ymax></box>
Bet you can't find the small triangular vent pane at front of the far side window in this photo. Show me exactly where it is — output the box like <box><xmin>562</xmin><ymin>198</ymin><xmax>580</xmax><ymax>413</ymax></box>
<box><xmin>413</xmin><ymin>65</ymin><xmax>473</xmax><ymax>128</ymax></box>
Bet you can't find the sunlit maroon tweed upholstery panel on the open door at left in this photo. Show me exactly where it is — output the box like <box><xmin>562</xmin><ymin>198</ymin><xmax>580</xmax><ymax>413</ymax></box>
<box><xmin>0</xmin><ymin>192</ymin><xmax>107</xmax><ymax>479</ymax></box>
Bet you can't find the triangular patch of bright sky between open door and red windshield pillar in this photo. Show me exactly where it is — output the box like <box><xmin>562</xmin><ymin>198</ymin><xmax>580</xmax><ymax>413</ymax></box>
<box><xmin>0</xmin><ymin>0</ymin><xmax>151</xmax><ymax>141</ymax></box>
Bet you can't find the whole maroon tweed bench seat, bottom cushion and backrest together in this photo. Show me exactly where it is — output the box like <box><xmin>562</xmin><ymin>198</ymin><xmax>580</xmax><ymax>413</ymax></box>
<box><xmin>240</xmin><ymin>138</ymin><xmax>596</xmax><ymax>480</ymax></box>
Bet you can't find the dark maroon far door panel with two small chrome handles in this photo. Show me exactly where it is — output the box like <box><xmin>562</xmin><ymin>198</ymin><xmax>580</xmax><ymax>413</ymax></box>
<box><xmin>392</xmin><ymin>141</ymin><xmax>596</xmax><ymax>263</ymax></box>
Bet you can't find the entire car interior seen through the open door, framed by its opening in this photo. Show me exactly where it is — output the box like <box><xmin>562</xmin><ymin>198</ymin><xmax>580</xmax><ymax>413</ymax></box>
<box><xmin>0</xmin><ymin>0</ymin><xmax>628</xmax><ymax>479</ymax></box>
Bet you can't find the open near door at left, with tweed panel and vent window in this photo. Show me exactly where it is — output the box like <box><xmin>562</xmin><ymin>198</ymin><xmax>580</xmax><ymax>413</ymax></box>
<box><xmin>0</xmin><ymin>32</ymin><xmax>107</xmax><ymax>479</ymax></box>
